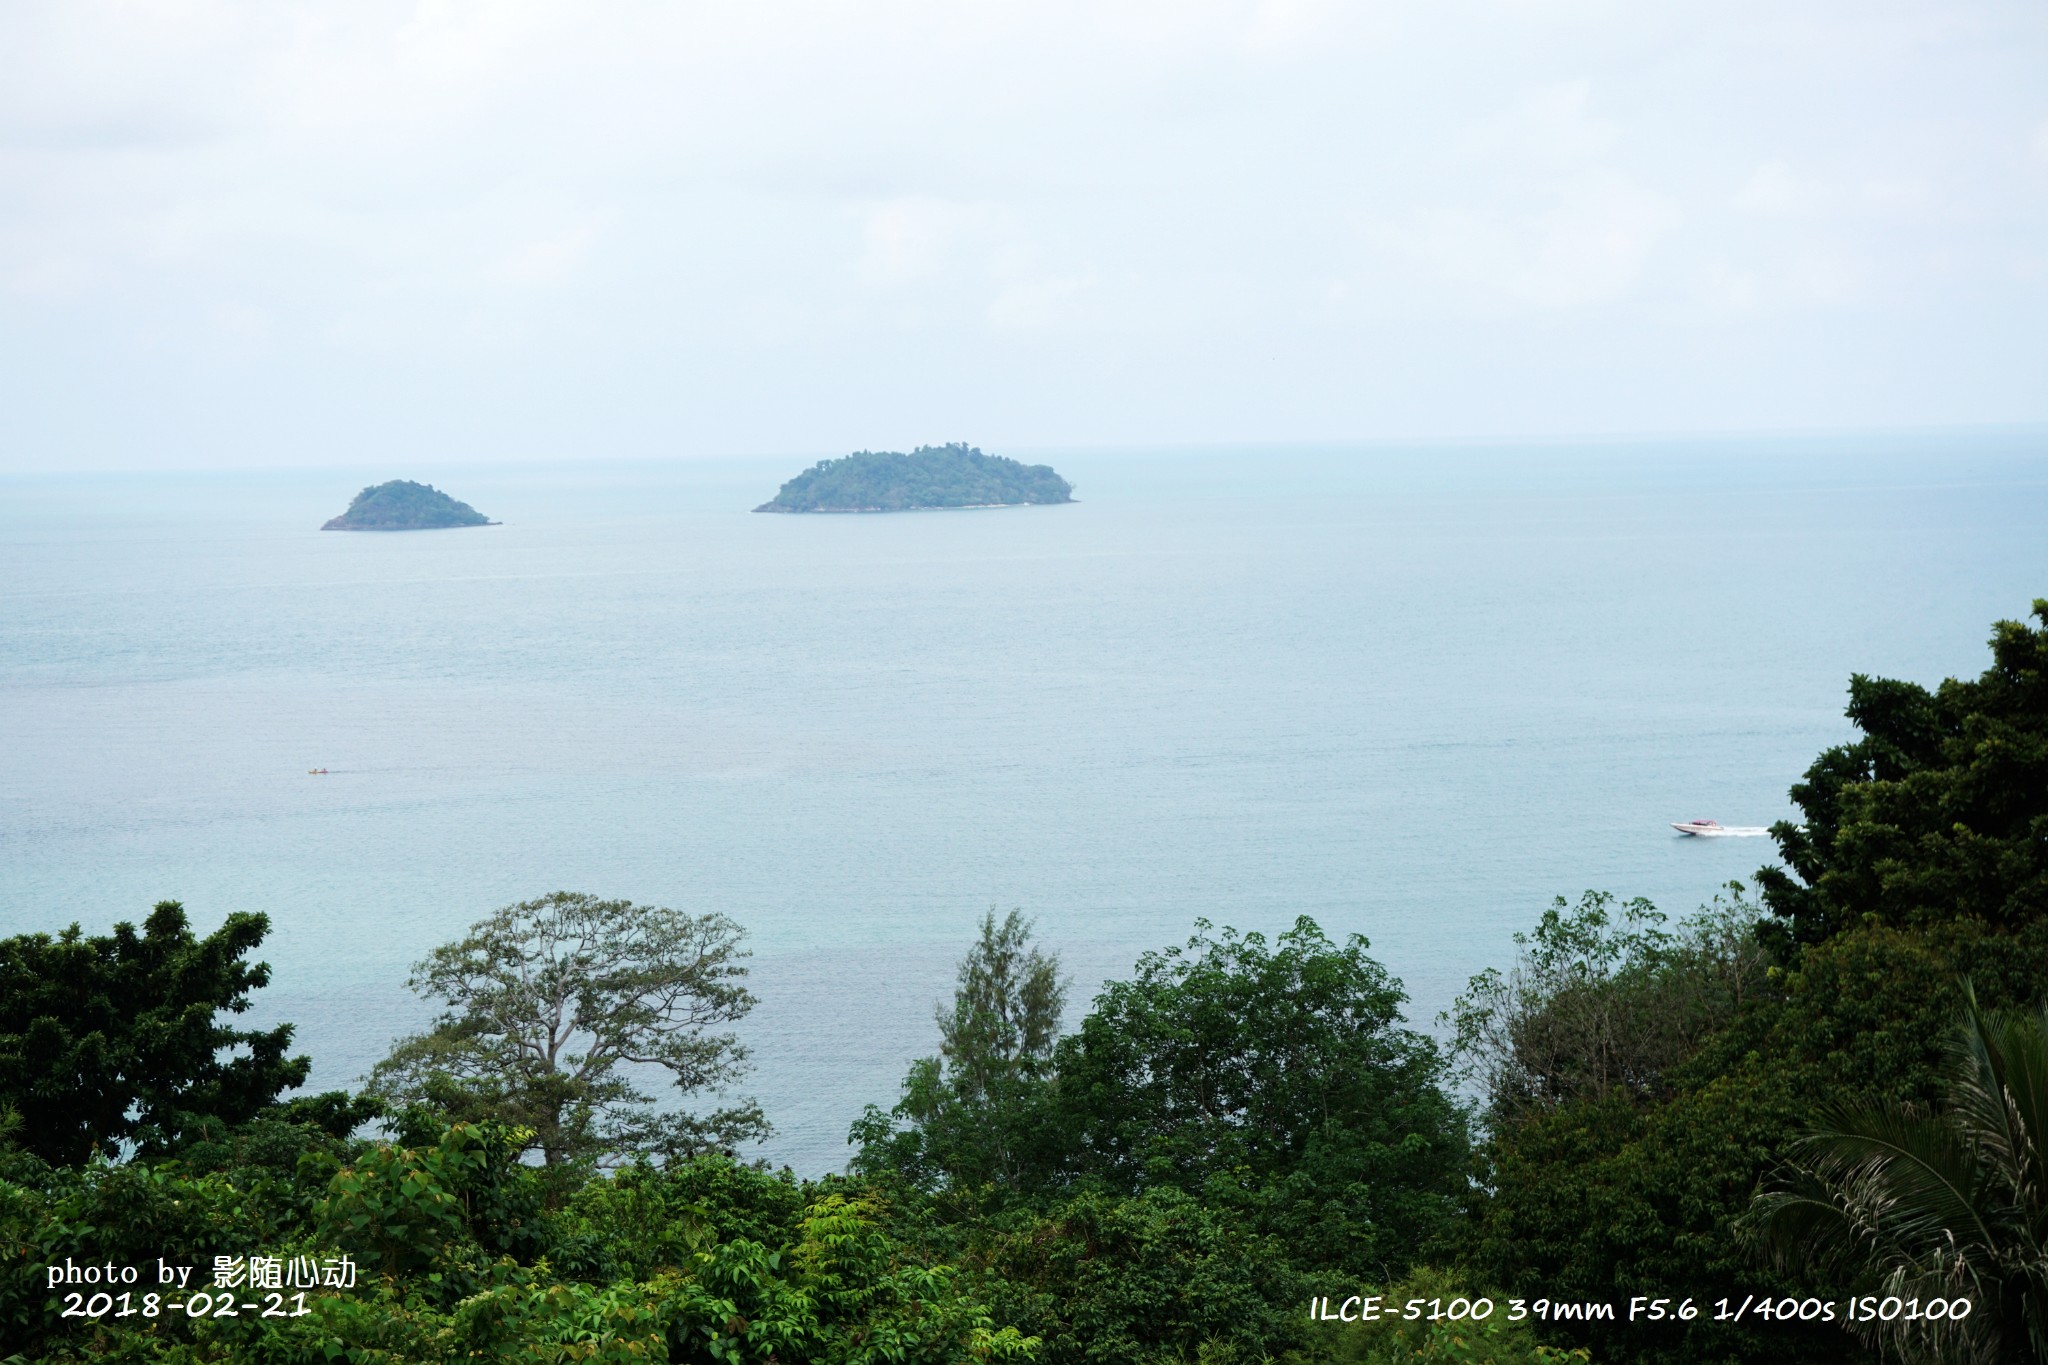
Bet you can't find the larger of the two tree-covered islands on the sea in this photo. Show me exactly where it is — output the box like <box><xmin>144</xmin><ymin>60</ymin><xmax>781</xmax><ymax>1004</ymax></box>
<box><xmin>756</xmin><ymin>444</ymin><xmax>1073</xmax><ymax>512</ymax></box>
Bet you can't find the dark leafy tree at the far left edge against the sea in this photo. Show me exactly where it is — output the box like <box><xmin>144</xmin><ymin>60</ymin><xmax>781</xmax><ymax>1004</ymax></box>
<box><xmin>0</xmin><ymin>900</ymin><xmax>311</xmax><ymax>1164</ymax></box>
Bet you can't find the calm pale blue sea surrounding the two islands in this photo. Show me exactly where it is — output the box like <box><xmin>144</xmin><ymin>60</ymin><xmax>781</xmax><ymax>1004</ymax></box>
<box><xmin>0</xmin><ymin>436</ymin><xmax>2048</xmax><ymax>1173</ymax></box>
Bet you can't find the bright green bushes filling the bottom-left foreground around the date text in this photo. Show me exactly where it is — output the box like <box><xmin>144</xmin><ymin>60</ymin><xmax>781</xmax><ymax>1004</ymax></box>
<box><xmin>0</xmin><ymin>1126</ymin><xmax>1036</xmax><ymax>1365</ymax></box>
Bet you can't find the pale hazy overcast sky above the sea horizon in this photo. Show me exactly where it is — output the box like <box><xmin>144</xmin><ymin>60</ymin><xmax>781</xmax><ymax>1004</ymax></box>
<box><xmin>0</xmin><ymin>0</ymin><xmax>2048</xmax><ymax>471</ymax></box>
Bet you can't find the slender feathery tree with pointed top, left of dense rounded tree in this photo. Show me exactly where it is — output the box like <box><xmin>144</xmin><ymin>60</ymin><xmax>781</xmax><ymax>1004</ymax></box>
<box><xmin>848</xmin><ymin>909</ymin><xmax>1067</xmax><ymax>1195</ymax></box>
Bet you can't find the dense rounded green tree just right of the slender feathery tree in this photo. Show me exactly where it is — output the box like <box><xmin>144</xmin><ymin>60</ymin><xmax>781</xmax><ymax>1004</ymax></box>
<box><xmin>1057</xmin><ymin>917</ymin><xmax>1466</xmax><ymax>1273</ymax></box>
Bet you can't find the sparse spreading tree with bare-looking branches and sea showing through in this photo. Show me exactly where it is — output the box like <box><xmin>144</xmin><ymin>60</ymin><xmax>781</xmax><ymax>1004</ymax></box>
<box><xmin>369</xmin><ymin>890</ymin><xmax>768</xmax><ymax>1164</ymax></box>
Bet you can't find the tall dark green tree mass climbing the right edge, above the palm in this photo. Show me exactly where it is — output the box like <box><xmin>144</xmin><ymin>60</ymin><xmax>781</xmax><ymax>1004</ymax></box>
<box><xmin>1468</xmin><ymin>606</ymin><xmax>2048</xmax><ymax>1365</ymax></box>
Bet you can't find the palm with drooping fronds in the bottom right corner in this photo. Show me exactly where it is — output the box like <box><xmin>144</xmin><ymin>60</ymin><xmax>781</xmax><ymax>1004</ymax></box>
<box><xmin>1749</xmin><ymin>993</ymin><xmax>2048</xmax><ymax>1363</ymax></box>
